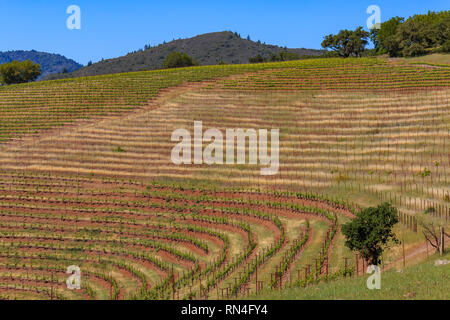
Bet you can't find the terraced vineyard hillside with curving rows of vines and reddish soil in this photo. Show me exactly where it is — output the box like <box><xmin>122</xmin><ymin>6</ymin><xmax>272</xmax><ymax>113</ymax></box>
<box><xmin>0</xmin><ymin>56</ymin><xmax>450</xmax><ymax>299</ymax></box>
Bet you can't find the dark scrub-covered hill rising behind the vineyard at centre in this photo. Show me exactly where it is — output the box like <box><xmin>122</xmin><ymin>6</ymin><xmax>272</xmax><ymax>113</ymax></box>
<box><xmin>46</xmin><ymin>31</ymin><xmax>324</xmax><ymax>80</ymax></box>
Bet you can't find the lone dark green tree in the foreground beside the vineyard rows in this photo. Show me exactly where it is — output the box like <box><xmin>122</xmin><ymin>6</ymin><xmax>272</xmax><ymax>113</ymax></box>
<box><xmin>342</xmin><ymin>203</ymin><xmax>398</xmax><ymax>265</ymax></box>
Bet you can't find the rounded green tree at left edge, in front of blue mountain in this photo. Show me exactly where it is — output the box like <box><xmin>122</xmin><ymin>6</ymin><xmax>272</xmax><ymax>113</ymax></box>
<box><xmin>0</xmin><ymin>60</ymin><xmax>42</xmax><ymax>84</ymax></box>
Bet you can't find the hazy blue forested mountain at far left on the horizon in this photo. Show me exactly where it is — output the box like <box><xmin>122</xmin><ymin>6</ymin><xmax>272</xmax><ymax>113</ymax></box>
<box><xmin>0</xmin><ymin>50</ymin><xmax>83</xmax><ymax>78</ymax></box>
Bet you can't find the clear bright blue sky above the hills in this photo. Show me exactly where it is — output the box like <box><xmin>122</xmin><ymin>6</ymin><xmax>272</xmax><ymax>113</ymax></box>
<box><xmin>0</xmin><ymin>0</ymin><xmax>450</xmax><ymax>64</ymax></box>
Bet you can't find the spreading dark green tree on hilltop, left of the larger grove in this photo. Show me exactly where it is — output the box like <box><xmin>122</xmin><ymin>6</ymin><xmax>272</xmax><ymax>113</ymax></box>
<box><xmin>322</xmin><ymin>27</ymin><xmax>369</xmax><ymax>58</ymax></box>
